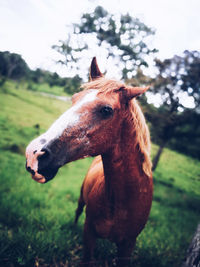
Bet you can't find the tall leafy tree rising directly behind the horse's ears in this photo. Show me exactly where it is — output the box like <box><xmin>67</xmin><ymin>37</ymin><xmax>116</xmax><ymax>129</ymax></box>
<box><xmin>53</xmin><ymin>6</ymin><xmax>157</xmax><ymax>79</ymax></box>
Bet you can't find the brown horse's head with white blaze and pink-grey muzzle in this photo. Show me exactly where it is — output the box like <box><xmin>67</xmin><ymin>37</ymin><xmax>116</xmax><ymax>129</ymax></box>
<box><xmin>26</xmin><ymin>58</ymin><xmax>147</xmax><ymax>183</ymax></box>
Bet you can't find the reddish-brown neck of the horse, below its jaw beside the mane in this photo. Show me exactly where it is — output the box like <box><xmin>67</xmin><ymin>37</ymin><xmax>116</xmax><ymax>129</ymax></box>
<box><xmin>102</xmin><ymin>119</ymin><xmax>145</xmax><ymax>204</ymax></box>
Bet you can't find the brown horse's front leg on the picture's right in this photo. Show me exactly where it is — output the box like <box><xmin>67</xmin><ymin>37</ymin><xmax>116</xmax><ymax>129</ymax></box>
<box><xmin>117</xmin><ymin>239</ymin><xmax>136</xmax><ymax>267</ymax></box>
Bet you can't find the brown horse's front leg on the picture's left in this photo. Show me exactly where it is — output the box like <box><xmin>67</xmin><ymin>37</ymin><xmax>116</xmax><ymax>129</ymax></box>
<box><xmin>82</xmin><ymin>219</ymin><xmax>96</xmax><ymax>267</ymax></box>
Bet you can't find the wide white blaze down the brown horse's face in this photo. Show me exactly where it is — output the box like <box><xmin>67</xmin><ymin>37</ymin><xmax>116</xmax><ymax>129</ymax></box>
<box><xmin>40</xmin><ymin>90</ymin><xmax>98</xmax><ymax>141</ymax></box>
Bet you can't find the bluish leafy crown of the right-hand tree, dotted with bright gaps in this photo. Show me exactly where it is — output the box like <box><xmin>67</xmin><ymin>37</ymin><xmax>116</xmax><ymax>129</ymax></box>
<box><xmin>153</xmin><ymin>51</ymin><xmax>200</xmax><ymax>113</ymax></box>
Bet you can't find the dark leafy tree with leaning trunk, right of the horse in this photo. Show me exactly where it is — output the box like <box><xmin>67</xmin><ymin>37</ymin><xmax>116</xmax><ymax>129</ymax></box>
<box><xmin>146</xmin><ymin>51</ymin><xmax>200</xmax><ymax>170</ymax></box>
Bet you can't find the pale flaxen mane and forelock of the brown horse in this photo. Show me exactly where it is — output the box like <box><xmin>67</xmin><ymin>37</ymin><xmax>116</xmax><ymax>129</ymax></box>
<box><xmin>82</xmin><ymin>77</ymin><xmax>152</xmax><ymax>176</ymax></box>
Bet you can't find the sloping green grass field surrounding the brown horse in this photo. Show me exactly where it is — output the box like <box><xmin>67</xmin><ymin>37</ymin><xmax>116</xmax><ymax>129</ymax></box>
<box><xmin>0</xmin><ymin>82</ymin><xmax>200</xmax><ymax>267</ymax></box>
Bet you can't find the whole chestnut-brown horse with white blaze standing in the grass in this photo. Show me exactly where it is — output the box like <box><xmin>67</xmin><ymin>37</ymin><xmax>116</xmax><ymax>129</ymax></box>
<box><xmin>26</xmin><ymin>58</ymin><xmax>153</xmax><ymax>266</ymax></box>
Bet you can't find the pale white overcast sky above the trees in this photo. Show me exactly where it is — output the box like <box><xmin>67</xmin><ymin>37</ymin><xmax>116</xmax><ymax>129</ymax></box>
<box><xmin>0</xmin><ymin>0</ymin><xmax>200</xmax><ymax>76</ymax></box>
